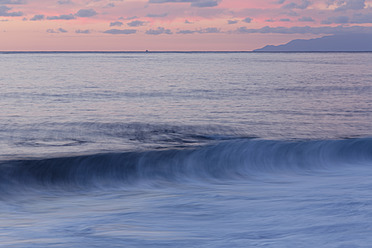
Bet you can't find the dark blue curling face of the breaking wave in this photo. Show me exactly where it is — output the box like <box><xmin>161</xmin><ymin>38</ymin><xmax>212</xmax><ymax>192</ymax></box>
<box><xmin>0</xmin><ymin>138</ymin><xmax>372</xmax><ymax>189</ymax></box>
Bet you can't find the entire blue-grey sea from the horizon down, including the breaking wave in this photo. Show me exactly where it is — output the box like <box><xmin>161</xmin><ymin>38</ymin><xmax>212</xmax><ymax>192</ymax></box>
<box><xmin>0</xmin><ymin>52</ymin><xmax>372</xmax><ymax>248</ymax></box>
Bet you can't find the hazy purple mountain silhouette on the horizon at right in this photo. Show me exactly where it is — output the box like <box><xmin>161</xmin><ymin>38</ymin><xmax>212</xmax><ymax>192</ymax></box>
<box><xmin>254</xmin><ymin>34</ymin><xmax>372</xmax><ymax>52</ymax></box>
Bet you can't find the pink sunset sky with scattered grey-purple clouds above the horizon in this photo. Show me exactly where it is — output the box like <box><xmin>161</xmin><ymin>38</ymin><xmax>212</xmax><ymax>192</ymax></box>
<box><xmin>0</xmin><ymin>0</ymin><xmax>372</xmax><ymax>51</ymax></box>
